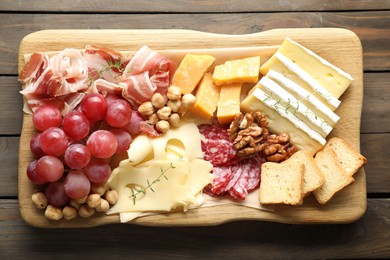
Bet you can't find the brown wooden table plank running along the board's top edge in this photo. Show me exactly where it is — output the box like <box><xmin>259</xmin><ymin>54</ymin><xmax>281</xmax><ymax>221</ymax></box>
<box><xmin>0</xmin><ymin>11</ymin><xmax>390</xmax><ymax>74</ymax></box>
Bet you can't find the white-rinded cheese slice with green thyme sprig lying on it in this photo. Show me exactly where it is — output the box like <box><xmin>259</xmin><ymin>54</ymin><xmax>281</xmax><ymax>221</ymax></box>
<box><xmin>259</xmin><ymin>77</ymin><xmax>333</xmax><ymax>137</ymax></box>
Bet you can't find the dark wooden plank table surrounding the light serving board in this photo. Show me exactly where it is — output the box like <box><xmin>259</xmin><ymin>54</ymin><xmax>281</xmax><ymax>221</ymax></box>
<box><xmin>0</xmin><ymin>0</ymin><xmax>390</xmax><ymax>259</ymax></box>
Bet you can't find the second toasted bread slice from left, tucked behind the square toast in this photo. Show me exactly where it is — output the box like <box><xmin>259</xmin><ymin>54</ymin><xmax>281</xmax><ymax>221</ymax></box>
<box><xmin>288</xmin><ymin>150</ymin><xmax>325</xmax><ymax>197</ymax></box>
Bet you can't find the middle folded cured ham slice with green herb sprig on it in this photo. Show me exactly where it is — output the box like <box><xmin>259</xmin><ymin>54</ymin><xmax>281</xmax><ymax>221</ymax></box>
<box><xmin>84</xmin><ymin>45</ymin><xmax>126</xmax><ymax>83</ymax></box>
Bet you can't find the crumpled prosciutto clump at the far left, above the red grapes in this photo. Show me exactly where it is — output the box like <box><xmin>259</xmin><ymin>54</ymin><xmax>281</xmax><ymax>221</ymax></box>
<box><xmin>19</xmin><ymin>49</ymin><xmax>88</xmax><ymax>114</ymax></box>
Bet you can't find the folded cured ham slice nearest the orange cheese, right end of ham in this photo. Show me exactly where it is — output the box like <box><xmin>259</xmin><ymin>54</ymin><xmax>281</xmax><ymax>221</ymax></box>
<box><xmin>122</xmin><ymin>46</ymin><xmax>175</xmax><ymax>79</ymax></box>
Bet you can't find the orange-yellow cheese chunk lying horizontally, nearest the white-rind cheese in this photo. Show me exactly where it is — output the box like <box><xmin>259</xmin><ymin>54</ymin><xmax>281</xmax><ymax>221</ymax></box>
<box><xmin>213</xmin><ymin>56</ymin><xmax>260</xmax><ymax>86</ymax></box>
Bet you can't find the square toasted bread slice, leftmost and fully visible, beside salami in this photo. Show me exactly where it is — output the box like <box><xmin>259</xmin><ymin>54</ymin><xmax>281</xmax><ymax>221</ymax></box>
<box><xmin>259</xmin><ymin>161</ymin><xmax>304</xmax><ymax>205</ymax></box>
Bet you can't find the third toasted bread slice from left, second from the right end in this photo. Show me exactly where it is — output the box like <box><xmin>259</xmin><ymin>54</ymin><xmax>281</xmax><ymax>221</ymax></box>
<box><xmin>313</xmin><ymin>147</ymin><xmax>354</xmax><ymax>204</ymax></box>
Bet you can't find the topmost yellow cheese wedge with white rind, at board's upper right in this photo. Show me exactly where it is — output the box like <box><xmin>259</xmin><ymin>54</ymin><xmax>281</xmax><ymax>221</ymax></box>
<box><xmin>278</xmin><ymin>38</ymin><xmax>352</xmax><ymax>98</ymax></box>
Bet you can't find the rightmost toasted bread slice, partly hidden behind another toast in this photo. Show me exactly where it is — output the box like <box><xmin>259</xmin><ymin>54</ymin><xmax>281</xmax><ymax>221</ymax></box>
<box><xmin>325</xmin><ymin>137</ymin><xmax>367</xmax><ymax>176</ymax></box>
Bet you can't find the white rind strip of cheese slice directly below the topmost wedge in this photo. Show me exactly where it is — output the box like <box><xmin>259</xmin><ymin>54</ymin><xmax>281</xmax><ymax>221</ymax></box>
<box><xmin>275</xmin><ymin>52</ymin><xmax>341</xmax><ymax>109</ymax></box>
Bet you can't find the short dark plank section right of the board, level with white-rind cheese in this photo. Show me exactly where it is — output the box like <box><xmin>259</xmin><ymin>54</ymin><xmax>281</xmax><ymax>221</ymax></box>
<box><xmin>360</xmin><ymin>73</ymin><xmax>390</xmax><ymax>133</ymax></box>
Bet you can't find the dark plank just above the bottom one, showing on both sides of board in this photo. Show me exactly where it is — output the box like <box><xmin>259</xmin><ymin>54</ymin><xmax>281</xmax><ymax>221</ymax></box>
<box><xmin>0</xmin><ymin>133</ymin><xmax>390</xmax><ymax>197</ymax></box>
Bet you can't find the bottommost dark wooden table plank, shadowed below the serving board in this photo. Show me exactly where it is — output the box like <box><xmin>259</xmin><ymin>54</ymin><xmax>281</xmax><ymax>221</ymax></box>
<box><xmin>0</xmin><ymin>199</ymin><xmax>390</xmax><ymax>259</ymax></box>
